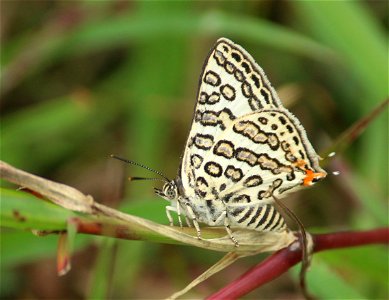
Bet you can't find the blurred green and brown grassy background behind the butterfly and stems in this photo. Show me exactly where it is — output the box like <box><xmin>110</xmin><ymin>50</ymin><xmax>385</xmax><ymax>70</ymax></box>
<box><xmin>0</xmin><ymin>1</ymin><xmax>389</xmax><ymax>299</ymax></box>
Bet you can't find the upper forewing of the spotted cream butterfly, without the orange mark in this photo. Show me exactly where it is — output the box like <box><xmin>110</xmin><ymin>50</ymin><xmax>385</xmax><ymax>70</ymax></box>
<box><xmin>181</xmin><ymin>38</ymin><xmax>281</xmax><ymax>194</ymax></box>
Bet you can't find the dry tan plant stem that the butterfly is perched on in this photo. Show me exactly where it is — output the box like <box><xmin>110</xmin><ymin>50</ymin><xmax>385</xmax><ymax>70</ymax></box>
<box><xmin>0</xmin><ymin>161</ymin><xmax>296</xmax><ymax>255</ymax></box>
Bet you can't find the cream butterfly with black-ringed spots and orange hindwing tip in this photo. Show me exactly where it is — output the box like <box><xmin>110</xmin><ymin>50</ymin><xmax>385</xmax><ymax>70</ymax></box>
<box><xmin>155</xmin><ymin>38</ymin><xmax>327</xmax><ymax>246</ymax></box>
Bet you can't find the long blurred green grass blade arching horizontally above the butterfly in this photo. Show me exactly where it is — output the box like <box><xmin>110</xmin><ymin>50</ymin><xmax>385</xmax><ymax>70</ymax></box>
<box><xmin>1</xmin><ymin>9</ymin><xmax>336</xmax><ymax>93</ymax></box>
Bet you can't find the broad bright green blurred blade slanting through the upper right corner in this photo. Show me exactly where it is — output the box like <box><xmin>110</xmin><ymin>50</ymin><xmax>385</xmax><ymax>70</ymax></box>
<box><xmin>293</xmin><ymin>1</ymin><xmax>388</xmax><ymax>102</ymax></box>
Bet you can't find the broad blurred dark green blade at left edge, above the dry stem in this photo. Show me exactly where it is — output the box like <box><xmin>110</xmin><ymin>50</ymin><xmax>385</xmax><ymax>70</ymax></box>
<box><xmin>0</xmin><ymin>94</ymin><xmax>121</xmax><ymax>170</ymax></box>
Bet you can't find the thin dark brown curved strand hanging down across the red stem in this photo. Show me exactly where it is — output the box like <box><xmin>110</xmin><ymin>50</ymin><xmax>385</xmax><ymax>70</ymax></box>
<box><xmin>273</xmin><ymin>196</ymin><xmax>314</xmax><ymax>299</ymax></box>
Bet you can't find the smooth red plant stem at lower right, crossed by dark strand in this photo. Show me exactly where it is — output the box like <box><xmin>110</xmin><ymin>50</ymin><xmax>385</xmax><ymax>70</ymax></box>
<box><xmin>207</xmin><ymin>228</ymin><xmax>389</xmax><ymax>300</ymax></box>
